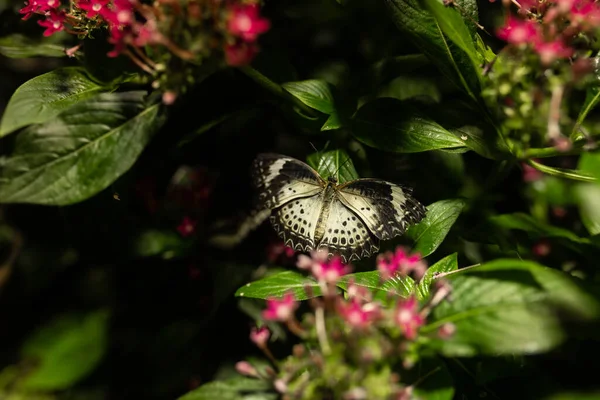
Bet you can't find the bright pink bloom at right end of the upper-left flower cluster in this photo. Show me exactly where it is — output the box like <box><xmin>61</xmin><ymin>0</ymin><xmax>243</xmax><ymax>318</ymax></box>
<box><xmin>225</xmin><ymin>4</ymin><xmax>271</xmax><ymax>67</ymax></box>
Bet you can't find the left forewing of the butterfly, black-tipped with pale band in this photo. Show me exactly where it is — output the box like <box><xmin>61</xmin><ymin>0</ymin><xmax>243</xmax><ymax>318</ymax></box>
<box><xmin>252</xmin><ymin>153</ymin><xmax>325</xmax><ymax>209</ymax></box>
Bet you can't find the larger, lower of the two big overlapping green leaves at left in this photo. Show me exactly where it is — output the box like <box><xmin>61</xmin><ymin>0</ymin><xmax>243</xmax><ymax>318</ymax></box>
<box><xmin>0</xmin><ymin>91</ymin><xmax>163</xmax><ymax>205</ymax></box>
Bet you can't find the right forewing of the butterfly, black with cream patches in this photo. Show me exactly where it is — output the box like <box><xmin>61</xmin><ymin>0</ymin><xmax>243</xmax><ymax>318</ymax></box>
<box><xmin>337</xmin><ymin>179</ymin><xmax>426</xmax><ymax>240</ymax></box>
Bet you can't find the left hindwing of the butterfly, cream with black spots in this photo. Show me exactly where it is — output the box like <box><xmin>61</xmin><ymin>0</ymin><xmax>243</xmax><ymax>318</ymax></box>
<box><xmin>271</xmin><ymin>194</ymin><xmax>323</xmax><ymax>251</ymax></box>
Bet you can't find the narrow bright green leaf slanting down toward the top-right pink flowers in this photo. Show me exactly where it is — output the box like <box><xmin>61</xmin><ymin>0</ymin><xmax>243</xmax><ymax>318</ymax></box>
<box><xmin>425</xmin><ymin>0</ymin><xmax>481</xmax><ymax>71</ymax></box>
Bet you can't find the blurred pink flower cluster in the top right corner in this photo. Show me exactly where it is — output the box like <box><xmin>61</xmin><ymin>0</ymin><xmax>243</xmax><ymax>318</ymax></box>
<box><xmin>497</xmin><ymin>0</ymin><xmax>600</xmax><ymax>65</ymax></box>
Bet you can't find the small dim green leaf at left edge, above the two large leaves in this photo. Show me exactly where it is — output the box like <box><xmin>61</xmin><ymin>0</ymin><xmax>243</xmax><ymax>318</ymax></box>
<box><xmin>0</xmin><ymin>33</ymin><xmax>66</xmax><ymax>58</ymax></box>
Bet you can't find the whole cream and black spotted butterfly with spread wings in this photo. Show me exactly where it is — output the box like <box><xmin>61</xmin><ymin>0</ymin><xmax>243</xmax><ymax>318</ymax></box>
<box><xmin>252</xmin><ymin>153</ymin><xmax>426</xmax><ymax>262</ymax></box>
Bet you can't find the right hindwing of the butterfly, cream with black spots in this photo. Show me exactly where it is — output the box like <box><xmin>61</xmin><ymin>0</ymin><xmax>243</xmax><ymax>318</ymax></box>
<box><xmin>318</xmin><ymin>197</ymin><xmax>379</xmax><ymax>262</ymax></box>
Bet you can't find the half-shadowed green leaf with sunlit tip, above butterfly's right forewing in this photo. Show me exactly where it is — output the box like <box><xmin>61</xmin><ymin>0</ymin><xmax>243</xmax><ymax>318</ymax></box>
<box><xmin>352</xmin><ymin>99</ymin><xmax>465</xmax><ymax>153</ymax></box>
